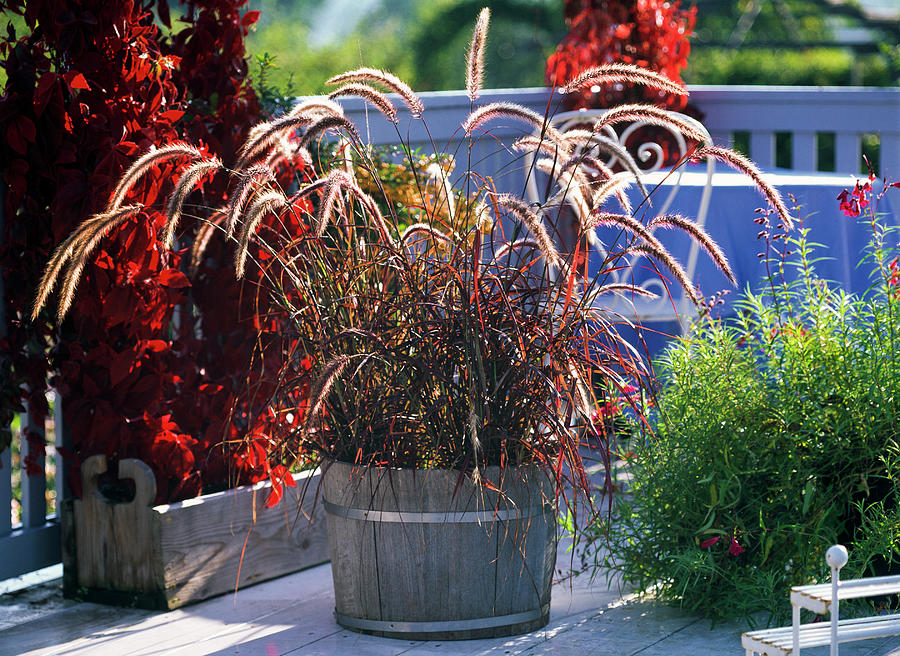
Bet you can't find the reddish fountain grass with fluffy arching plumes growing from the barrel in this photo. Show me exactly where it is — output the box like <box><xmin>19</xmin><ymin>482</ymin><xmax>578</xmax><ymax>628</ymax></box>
<box><xmin>36</xmin><ymin>10</ymin><xmax>790</xmax><ymax>512</ymax></box>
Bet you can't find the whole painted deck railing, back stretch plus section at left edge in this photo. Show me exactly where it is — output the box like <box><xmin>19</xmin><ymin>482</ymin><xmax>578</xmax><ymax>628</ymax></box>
<box><xmin>0</xmin><ymin>86</ymin><xmax>900</xmax><ymax>580</ymax></box>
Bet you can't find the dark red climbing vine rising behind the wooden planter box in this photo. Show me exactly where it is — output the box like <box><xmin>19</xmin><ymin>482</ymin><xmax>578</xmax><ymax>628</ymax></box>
<box><xmin>0</xmin><ymin>0</ymin><xmax>306</xmax><ymax>502</ymax></box>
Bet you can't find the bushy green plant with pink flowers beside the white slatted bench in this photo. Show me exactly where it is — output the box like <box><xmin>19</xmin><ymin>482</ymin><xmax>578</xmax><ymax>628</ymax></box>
<box><xmin>589</xmin><ymin>191</ymin><xmax>900</xmax><ymax>621</ymax></box>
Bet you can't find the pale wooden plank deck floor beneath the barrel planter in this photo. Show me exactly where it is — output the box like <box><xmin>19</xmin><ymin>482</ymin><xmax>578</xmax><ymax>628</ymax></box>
<box><xmin>0</xmin><ymin>553</ymin><xmax>900</xmax><ymax>656</ymax></box>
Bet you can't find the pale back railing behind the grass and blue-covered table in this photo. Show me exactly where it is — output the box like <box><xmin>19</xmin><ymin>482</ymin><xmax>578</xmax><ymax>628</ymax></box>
<box><xmin>345</xmin><ymin>86</ymin><xmax>900</xmax><ymax>182</ymax></box>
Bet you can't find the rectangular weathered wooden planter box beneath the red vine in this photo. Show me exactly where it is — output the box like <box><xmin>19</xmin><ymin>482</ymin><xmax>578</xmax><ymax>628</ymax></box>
<box><xmin>62</xmin><ymin>456</ymin><xmax>328</xmax><ymax>610</ymax></box>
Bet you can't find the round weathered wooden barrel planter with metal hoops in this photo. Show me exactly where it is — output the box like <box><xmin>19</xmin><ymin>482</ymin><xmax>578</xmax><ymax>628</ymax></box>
<box><xmin>323</xmin><ymin>462</ymin><xmax>556</xmax><ymax>640</ymax></box>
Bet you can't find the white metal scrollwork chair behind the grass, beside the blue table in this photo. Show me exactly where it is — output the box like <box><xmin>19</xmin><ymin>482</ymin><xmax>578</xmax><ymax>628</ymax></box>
<box><xmin>525</xmin><ymin>110</ymin><xmax>715</xmax><ymax>333</ymax></box>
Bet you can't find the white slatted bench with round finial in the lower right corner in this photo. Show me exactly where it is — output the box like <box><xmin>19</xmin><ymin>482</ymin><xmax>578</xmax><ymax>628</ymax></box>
<box><xmin>741</xmin><ymin>545</ymin><xmax>900</xmax><ymax>656</ymax></box>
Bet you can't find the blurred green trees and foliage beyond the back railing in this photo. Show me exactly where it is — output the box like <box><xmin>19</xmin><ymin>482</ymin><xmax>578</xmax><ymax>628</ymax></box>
<box><xmin>247</xmin><ymin>0</ymin><xmax>900</xmax><ymax>94</ymax></box>
